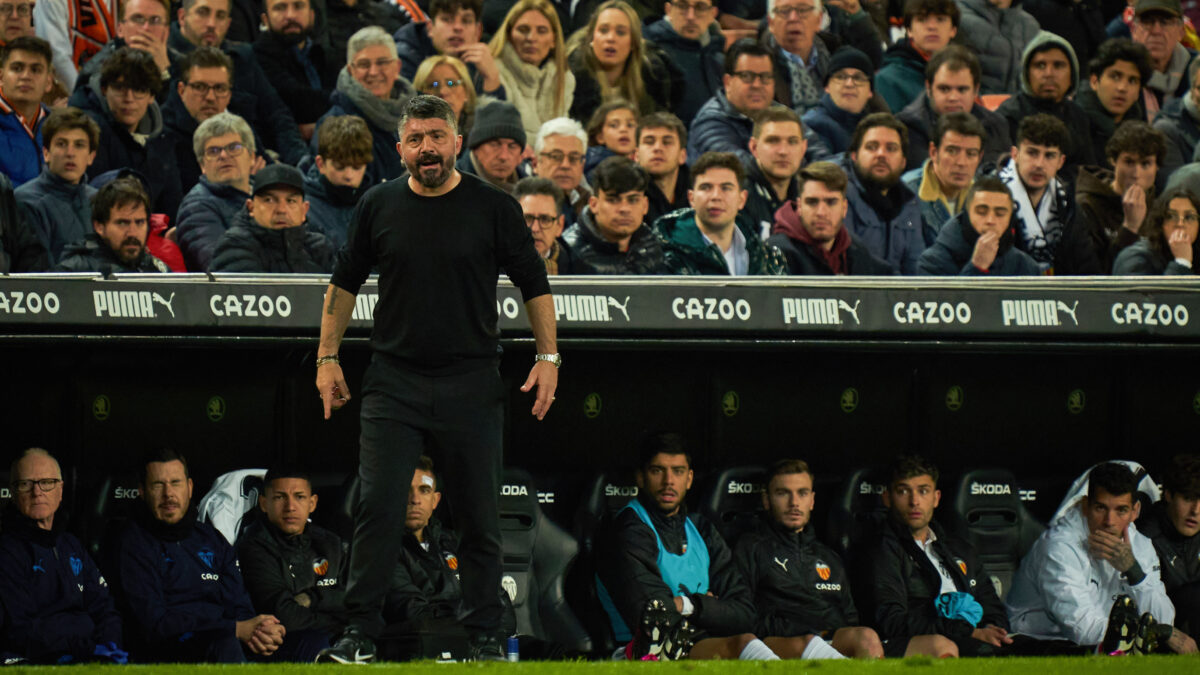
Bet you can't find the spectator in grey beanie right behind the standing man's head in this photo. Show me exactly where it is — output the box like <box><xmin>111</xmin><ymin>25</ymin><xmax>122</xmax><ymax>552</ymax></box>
<box><xmin>456</xmin><ymin>101</ymin><xmax>528</xmax><ymax>195</ymax></box>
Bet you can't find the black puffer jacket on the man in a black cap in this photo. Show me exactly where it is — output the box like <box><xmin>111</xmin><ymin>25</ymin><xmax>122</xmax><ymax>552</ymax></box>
<box><xmin>209</xmin><ymin>208</ymin><xmax>337</xmax><ymax>274</ymax></box>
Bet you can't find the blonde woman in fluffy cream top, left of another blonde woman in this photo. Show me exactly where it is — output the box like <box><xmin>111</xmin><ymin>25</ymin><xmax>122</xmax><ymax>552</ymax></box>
<box><xmin>490</xmin><ymin>0</ymin><xmax>575</xmax><ymax>137</ymax></box>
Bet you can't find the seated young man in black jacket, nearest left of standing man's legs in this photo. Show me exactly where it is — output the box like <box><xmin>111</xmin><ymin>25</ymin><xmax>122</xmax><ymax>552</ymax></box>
<box><xmin>236</xmin><ymin>468</ymin><xmax>346</xmax><ymax>662</ymax></box>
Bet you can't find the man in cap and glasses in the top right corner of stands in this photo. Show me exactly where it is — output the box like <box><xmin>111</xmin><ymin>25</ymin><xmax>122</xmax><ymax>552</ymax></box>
<box><xmin>1129</xmin><ymin>0</ymin><xmax>1195</xmax><ymax>111</ymax></box>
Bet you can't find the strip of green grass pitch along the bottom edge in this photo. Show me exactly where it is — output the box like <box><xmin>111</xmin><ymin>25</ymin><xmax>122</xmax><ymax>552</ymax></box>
<box><xmin>4</xmin><ymin>656</ymin><xmax>1200</xmax><ymax>675</ymax></box>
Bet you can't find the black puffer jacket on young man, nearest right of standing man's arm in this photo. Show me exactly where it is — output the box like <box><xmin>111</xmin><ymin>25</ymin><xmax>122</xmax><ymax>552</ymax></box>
<box><xmin>563</xmin><ymin>208</ymin><xmax>667</xmax><ymax>274</ymax></box>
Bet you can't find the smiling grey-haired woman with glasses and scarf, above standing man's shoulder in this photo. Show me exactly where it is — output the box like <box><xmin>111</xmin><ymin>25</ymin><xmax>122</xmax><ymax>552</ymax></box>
<box><xmin>313</xmin><ymin>26</ymin><xmax>416</xmax><ymax>185</ymax></box>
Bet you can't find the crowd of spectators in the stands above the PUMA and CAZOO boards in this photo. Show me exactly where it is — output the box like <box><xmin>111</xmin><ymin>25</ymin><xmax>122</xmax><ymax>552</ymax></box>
<box><xmin>0</xmin><ymin>0</ymin><xmax>1200</xmax><ymax>276</ymax></box>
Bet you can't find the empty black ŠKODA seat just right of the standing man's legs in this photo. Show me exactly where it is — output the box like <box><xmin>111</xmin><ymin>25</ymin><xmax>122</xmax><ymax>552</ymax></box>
<box><xmin>500</xmin><ymin>468</ymin><xmax>592</xmax><ymax>652</ymax></box>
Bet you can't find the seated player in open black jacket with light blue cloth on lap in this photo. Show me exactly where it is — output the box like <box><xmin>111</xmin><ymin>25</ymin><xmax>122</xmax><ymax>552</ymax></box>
<box><xmin>869</xmin><ymin>455</ymin><xmax>1013</xmax><ymax>657</ymax></box>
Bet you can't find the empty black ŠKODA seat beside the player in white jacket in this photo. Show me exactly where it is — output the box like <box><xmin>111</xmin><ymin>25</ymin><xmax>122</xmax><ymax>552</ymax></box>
<box><xmin>938</xmin><ymin>468</ymin><xmax>1045</xmax><ymax>599</ymax></box>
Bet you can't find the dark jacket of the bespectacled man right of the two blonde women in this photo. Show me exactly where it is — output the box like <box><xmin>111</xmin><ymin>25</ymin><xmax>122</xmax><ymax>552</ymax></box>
<box><xmin>642</xmin><ymin>19</ymin><xmax>725</xmax><ymax>126</ymax></box>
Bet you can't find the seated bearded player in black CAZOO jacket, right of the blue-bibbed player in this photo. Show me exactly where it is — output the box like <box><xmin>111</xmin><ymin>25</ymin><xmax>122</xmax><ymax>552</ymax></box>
<box><xmin>733</xmin><ymin>459</ymin><xmax>883</xmax><ymax>658</ymax></box>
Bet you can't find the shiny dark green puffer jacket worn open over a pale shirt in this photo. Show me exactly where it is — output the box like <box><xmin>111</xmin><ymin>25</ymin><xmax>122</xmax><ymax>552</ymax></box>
<box><xmin>654</xmin><ymin>208</ymin><xmax>787</xmax><ymax>276</ymax></box>
